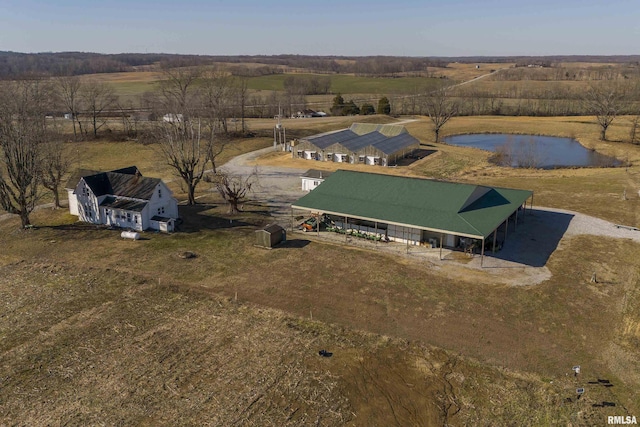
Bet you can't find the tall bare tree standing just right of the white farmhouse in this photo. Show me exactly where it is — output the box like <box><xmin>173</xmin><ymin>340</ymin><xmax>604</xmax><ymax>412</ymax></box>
<box><xmin>158</xmin><ymin>120</ymin><xmax>211</xmax><ymax>205</ymax></box>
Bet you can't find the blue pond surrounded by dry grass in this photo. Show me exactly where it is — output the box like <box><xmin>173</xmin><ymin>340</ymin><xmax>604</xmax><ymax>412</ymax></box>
<box><xmin>443</xmin><ymin>134</ymin><xmax>621</xmax><ymax>169</ymax></box>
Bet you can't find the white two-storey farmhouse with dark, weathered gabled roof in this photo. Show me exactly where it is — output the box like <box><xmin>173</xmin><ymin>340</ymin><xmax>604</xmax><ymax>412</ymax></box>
<box><xmin>66</xmin><ymin>166</ymin><xmax>178</xmax><ymax>232</ymax></box>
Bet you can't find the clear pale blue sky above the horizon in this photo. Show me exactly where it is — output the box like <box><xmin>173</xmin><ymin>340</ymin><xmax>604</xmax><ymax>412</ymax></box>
<box><xmin>0</xmin><ymin>0</ymin><xmax>640</xmax><ymax>56</ymax></box>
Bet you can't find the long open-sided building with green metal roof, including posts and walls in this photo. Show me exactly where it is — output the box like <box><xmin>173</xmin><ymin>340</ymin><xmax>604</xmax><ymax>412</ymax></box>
<box><xmin>292</xmin><ymin>170</ymin><xmax>533</xmax><ymax>264</ymax></box>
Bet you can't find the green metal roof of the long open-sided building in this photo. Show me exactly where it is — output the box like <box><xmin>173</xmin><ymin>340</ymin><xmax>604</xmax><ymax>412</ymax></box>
<box><xmin>292</xmin><ymin>170</ymin><xmax>533</xmax><ymax>238</ymax></box>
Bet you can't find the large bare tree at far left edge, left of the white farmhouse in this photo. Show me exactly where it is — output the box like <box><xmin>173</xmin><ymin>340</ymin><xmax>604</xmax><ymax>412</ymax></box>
<box><xmin>0</xmin><ymin>81</ymin><xmax>51</xmax><ymax>228</ymax></box>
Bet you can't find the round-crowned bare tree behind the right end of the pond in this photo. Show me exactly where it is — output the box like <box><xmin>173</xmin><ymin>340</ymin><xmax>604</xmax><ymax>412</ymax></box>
<box><xmin>583</xmin><ymin>82</ymin><xmax>624</xmax><ymax>141</ymax></box>
